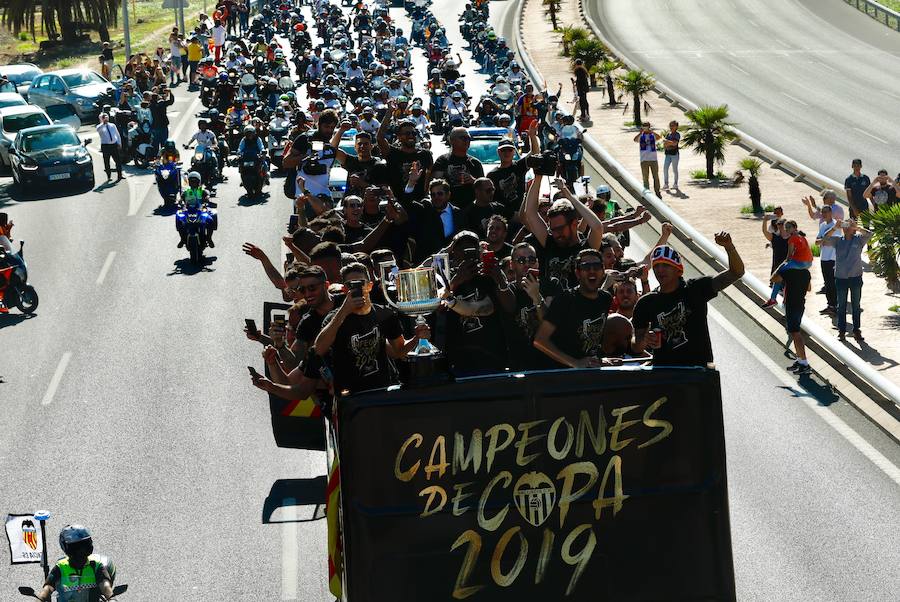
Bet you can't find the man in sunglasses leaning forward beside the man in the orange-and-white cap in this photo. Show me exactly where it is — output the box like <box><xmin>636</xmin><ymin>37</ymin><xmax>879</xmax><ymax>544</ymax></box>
<box><xmin>534</xmin><ymin>249</ymin><xmax>612</xmax><ymax>368</ymax></box>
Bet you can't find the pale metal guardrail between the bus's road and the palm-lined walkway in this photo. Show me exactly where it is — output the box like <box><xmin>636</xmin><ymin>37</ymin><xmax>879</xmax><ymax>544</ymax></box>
<box><xmin>512</xmin><ymin>0</ymin><xmax>900</xmax><ymax>405</ymax></box>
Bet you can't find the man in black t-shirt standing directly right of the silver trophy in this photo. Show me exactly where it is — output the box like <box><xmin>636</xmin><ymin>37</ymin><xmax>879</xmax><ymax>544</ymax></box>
<box><xmin>443</xmin><ymin>230</ymin><xmax>515</xmax><ymax>376</ymax></box>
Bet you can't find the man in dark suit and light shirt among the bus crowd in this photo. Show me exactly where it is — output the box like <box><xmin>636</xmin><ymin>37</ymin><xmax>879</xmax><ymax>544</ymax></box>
<box><xmin>407</xmin><ymin>175</ymin><xmax>466</xmax><ymax>265</ymax></box>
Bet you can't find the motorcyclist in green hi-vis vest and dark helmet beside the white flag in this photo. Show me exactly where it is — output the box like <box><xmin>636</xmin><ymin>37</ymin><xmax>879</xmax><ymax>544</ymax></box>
<box><xmin>37</xmin><ymin>525</ymin><xmax>116</xmax><ymax>602</ymax></box>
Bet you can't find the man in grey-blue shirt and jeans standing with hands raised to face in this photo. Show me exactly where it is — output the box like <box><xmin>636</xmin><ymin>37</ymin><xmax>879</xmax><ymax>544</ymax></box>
<box><xmin>822</xmin><ymin>220</ymin><xmax>872</xmax><ymax>342</ymax></box>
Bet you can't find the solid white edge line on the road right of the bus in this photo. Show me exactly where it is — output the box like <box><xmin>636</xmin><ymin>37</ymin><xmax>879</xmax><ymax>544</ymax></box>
<box><xmin>709</xmin><ymin>307</ymin><xmax>900</xmax><ymax>485</ymax></box>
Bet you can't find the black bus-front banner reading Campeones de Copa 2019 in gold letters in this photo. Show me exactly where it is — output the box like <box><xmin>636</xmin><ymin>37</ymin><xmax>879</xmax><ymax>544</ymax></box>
<box><xmin>338</xmin><ymin>369</ymin><xmax>735</xmax><ymax>602</ymax></box>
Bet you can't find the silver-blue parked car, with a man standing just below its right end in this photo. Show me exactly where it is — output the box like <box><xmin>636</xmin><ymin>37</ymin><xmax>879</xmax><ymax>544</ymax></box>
<box><xmin>28</xmin><ymin>69</ymin><xmax>115</xmax><ymax>121</ymax></box>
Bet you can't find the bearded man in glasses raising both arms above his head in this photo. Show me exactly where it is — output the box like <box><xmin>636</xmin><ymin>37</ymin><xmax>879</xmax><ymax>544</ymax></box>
<box><xmin>525</xmin><ymin>174</ymin><xmax>603</xmax><ymax>288</ymax></box>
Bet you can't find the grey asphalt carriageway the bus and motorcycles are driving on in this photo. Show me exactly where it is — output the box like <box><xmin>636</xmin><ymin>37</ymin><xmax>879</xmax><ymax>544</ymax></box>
<box><xmin>0</xmin><ymin>2</ymin><xmax>900</xmax><ymax>602</ymax></box>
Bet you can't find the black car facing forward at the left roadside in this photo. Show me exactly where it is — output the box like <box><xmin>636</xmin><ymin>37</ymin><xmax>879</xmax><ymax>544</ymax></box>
<box><xmin>9</xmin><ymin>125</ymin><xmax>94</xmax><ymax>188</ymax></box>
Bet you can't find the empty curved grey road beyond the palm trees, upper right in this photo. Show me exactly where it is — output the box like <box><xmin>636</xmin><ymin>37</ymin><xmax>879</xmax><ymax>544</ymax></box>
<box><xmin>585</xmin><ymin>0</ymin><xmax>900</xmax><ymax>182</ymax></box>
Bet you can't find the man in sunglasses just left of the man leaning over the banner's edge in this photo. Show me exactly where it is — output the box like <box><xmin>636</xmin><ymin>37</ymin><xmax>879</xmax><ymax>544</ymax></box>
<box><xmin>504</xmin><ymin>243</ymin><xmax>562</xmax><ymax>370</ymax></box>
